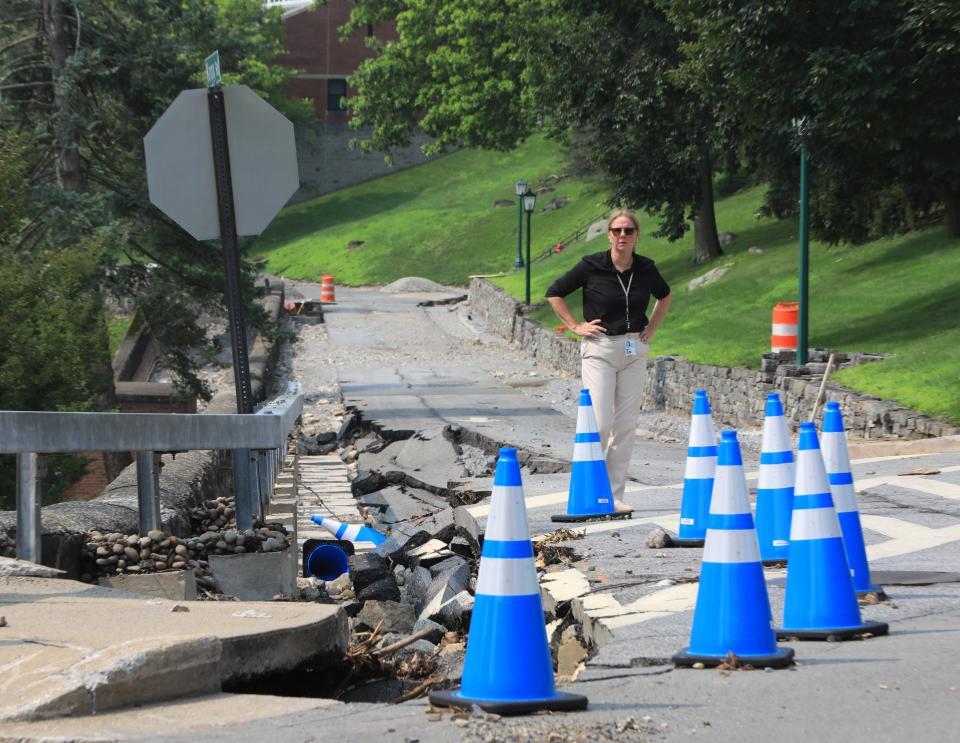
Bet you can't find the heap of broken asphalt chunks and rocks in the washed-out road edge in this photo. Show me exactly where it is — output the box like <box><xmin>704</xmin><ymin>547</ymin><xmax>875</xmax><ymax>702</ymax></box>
<box><xmin>320</xmin><ymin>412</ymin><xmax>589</xmax><ymax>701</ymax></box>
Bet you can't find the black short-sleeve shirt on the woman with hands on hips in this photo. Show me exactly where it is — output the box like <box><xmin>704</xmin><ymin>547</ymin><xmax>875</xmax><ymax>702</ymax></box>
<box><xmin>547</xmin><ymin>250</ymin><xmax>670</xmax><ymax>335</ymax></box>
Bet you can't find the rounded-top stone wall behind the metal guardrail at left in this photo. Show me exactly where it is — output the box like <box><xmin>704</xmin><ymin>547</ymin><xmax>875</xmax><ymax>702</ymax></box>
<box><xmin>0</xmin><ymin>286</ymin><xmax>283</xmax><ymax>579</ymax></box>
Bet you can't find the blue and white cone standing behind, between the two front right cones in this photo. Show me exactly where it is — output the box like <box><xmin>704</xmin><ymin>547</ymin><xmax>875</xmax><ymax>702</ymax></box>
<box><xmin>757</xmin><ymin>392</ymin><xmax>796</xmax><ymax>563</ymax></box>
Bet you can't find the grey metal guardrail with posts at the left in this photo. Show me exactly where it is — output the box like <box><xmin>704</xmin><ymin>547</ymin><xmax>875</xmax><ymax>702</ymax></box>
<box><xmin>0</xmin><ymin>384</ymin><xmax>303</xmax><ymax>562</ymax></box>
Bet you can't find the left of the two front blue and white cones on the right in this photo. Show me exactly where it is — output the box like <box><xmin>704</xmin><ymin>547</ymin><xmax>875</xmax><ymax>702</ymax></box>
<box><xmin>673</xmin><ymin>431</ymin><xmax>793</xmax><ymax>668</ymax></box>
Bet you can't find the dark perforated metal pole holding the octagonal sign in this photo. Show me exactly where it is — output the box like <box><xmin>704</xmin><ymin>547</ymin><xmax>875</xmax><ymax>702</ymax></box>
<box><xmin>207</xmin><ymin>86</ymin><xmax>253</xmax><ymax>414</ymax></box>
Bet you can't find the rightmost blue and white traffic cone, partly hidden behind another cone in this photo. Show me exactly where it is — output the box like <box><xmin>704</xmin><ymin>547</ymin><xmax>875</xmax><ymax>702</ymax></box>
<box><xmin>823</xmin><ymin>402</ymin><xmax>883</xmax><ymax>593</ymax></box>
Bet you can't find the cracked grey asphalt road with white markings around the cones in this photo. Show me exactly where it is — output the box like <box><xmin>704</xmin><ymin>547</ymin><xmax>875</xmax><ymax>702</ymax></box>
<box><xmin>240</xmin><ymin>288</ymin><xmax>960</xmax><ymax>743</ymax></box>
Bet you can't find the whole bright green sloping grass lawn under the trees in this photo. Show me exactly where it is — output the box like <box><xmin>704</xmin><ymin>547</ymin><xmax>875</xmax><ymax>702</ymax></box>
<box><xmin>256</xmin><ymin>137</ymin><xmax>960</xmax><ymax>423</ymax></box>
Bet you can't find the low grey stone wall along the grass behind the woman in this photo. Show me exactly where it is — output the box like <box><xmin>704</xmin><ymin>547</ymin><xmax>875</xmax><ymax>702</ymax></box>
<box><xmin>469</xmin><ymin>278</ymin><xmax>960</xmax><ymax>439</ymax></box>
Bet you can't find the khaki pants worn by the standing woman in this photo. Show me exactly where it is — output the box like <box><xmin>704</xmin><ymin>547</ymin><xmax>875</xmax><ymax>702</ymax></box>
<box><xmin>580</xmin><ymin>333</ymin><xmax>650</xmax><ymax>500</ymax></box>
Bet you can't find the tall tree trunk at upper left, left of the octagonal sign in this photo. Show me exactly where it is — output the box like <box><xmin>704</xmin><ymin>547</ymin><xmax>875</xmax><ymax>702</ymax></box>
<box><xmin>43</xmin><ymin>0</ymin><xmax>84</xmax><ymax>191</ymax></box>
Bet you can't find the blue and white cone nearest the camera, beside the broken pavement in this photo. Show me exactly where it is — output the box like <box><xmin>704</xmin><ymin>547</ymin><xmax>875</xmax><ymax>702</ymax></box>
<box><xmin>430</xmin><ymin>449</ymin><xmax>587</xmax><ymax>714</ymax></box>
